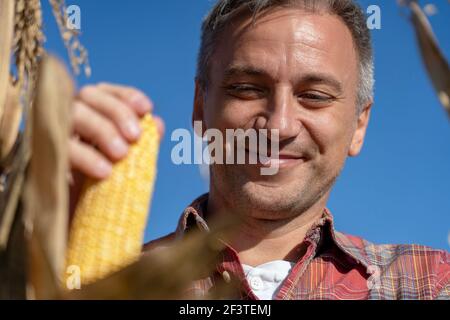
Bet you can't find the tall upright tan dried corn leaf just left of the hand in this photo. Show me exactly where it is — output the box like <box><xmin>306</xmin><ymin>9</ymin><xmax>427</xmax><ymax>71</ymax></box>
<box><xmin>25</xmin><ymin>56</ymin><xmax>74</xmax><ymax>298</ymax></box>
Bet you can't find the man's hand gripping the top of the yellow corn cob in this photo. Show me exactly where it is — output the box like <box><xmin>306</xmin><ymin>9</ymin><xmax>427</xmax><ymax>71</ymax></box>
<box><xmin>69</xmin><ymin>83</ymin><xmax>164</xmax><ymax>212</ymax></box>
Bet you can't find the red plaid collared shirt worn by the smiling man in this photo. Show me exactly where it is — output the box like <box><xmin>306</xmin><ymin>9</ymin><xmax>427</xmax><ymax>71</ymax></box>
<box><xmin>144</xmin><ymin>194</ymin><xmax>450</xmax><ymax>300</ymax></box>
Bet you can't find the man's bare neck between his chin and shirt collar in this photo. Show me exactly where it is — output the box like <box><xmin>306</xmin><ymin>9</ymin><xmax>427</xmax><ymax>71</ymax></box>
<box><xmin>207</xmin><ymin>192</ymin><xmax>328</xmax><ymax>266</ymax></box>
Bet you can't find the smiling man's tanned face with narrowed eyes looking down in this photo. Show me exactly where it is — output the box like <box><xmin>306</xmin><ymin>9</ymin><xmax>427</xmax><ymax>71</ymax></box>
<box><xmin>194</xmin><ymin>9</ymin><xmax>370</xmax><ymax>219</ymax></box>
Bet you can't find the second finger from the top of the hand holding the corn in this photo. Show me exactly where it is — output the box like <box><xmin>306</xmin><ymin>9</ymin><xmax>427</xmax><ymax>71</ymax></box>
<box><xmin>80</xmin><ymin>86</ymin><xmax>141</xmax><ymax>142</ymax></box>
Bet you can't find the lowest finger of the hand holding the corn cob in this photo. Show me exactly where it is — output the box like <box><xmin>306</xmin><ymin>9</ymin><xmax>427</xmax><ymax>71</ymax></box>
<box><xmin>69</xmin><ymin>138</ymin><xmax>112</xmax><ymax>179</ymax></box>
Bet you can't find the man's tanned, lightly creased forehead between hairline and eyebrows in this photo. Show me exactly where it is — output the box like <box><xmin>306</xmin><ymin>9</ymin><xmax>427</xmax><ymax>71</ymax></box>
<box><xmin>215</xmin><ymin>9</ymin><xmax>357</xmax><ymax>82</ymax></box>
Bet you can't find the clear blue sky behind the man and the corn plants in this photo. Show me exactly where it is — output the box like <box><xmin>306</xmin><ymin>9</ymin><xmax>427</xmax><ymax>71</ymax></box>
<box><xmin>40</xmin><ymin>0</ymin><xmax>450</xmax><ymax>250</ymax></box>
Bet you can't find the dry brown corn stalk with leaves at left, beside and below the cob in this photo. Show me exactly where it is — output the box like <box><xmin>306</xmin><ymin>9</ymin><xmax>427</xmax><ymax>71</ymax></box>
<box><xmin>0</xmin><ymin>0</ymin><xmax>237</xmax><ymax>299</ymax></box>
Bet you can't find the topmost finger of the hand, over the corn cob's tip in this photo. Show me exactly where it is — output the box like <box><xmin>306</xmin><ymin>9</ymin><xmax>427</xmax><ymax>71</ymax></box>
<box><xmin>98</xmin><ymin>82</ymin><xmax>153</xmax><ymax>117</ymax></box>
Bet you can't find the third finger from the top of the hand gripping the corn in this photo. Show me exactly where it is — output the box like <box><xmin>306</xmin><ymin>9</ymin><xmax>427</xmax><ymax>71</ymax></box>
<box><xmin>73</xmin><ymin>102</ymin><xmax>129</xmax><ymax>161</ymax></box>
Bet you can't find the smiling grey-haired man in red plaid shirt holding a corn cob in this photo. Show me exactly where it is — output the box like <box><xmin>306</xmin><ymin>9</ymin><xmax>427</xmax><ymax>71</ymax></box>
<box><xmin>71</xmin><ymin>0</ymin><xmax>450</xmax><ymax>299</ymax></box>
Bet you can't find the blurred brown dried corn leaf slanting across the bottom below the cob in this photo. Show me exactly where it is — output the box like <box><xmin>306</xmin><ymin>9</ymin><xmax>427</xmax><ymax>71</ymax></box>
<box><xmin>62</xmin><ymin>222</ymin><xmax>236</xmax><ymax>300</ymax></box>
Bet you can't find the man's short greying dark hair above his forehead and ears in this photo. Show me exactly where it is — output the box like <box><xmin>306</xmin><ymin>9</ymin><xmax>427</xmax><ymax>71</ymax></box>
<box><xmin>196</xmin><ymin>0</ymin><xmax>375</xmax><ymax>112</ymax></box>
